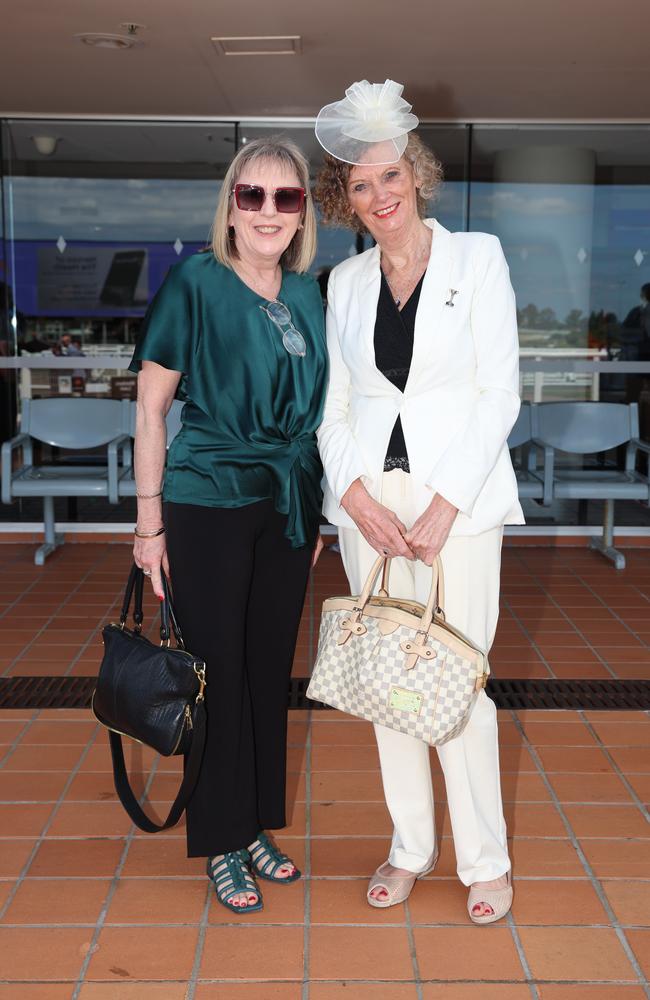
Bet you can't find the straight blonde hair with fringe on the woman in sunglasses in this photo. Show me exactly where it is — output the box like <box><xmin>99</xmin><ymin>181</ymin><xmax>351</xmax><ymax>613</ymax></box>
<box><xmin>210</xmin><ymin>136</ymin><xmax>317</xmax><ymax>273</ymax></box>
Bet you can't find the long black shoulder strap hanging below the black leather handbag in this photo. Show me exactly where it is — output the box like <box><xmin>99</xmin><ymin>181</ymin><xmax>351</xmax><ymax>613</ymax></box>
<box><xmin>108</xmin><ymin>698</ymin><xmax>206</xmax><ymax>833</ymax></box>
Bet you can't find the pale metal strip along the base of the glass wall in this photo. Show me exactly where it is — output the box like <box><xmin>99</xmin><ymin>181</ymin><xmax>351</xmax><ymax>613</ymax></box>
<box><xmin>0</xmin><ymin>521</ymin><xmax>650</xmax><ymax>538</ymax></box>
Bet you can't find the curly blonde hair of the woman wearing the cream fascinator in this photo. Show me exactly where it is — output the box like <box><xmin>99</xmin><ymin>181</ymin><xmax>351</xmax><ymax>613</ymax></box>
<box><xmin>314</xmin><ymin>132</ymin><xmax>443</xmax><ymax>233</ymax></box>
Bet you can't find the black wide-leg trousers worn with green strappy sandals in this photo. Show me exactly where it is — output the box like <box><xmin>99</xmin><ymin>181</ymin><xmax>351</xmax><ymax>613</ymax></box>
<box><xmin>164</xmin><ymin>500</ymin><xmax>312</xmax><ymax>857</ymax></box>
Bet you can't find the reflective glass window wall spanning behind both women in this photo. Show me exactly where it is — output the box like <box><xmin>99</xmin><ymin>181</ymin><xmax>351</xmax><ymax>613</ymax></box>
<box><xmin>0</xmin><ymin>120</ymin><xmax>650</xmax><ymax>524</ymax></box>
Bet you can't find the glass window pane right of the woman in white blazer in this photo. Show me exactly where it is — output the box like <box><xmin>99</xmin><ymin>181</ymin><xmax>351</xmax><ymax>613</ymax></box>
<box><xmin>469</xmin><ymin>125</ymin><xmax>650</xmax><ymax>398</ymax></box>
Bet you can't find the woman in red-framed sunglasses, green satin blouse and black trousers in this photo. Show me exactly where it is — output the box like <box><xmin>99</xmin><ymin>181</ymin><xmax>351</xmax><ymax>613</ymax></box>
<box><xmin>131</xmin><ymin>138</ymin><xmax>327</xmax><ymax>912</ymax></box>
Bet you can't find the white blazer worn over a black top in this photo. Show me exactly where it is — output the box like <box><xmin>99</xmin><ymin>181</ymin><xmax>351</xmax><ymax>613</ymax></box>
<box><xmin>318</xmin><ymin>219</ymin><xmax>524</xmax><ymax>535</ymax></box>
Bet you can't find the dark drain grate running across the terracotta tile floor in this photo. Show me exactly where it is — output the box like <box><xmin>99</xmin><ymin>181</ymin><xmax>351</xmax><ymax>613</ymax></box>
<box><xmin>0</xmin><ymin>677</ymin><xmax>650</xmax><ymax>712</ymax></box>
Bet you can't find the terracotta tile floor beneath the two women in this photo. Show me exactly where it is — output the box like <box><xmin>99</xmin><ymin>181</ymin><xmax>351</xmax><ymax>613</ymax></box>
<box><xmin>0</xmin><ymin>544</ymin><xmax>650</xmax><ymax>1000</ymax></box>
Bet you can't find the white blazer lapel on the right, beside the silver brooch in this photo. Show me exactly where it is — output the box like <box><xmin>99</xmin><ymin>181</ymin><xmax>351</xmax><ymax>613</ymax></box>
<box><xmin>404</xmin><ymin>219</ymin><xmax>452</xmax><ymax>392</ymax></box>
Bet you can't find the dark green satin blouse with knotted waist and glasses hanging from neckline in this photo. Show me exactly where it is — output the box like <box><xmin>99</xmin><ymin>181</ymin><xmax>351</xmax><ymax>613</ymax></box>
<box><xmin>129</xmin><ymin>253</ymin><xmax>327</xmax><ymax>548</ymax></box>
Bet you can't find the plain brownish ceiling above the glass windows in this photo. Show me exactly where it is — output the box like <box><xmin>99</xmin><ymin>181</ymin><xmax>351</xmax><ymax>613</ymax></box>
<box><xmin>0</xmin><ymin>0</ymin><xmax>650</xmax><ymax>121</ymax></box>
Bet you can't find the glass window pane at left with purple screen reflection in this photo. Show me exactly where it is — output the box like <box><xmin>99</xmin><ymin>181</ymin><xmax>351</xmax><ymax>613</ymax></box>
<box><xmin>4</xmin><ymin>121</ymin><xmax>235</xmax><ymax>350</ymax></box>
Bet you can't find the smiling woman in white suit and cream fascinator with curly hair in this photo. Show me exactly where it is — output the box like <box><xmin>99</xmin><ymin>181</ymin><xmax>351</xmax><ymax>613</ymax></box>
<box><xmin>316</xmin><ymin>81</ymin><xmax>523</xmax><ymax>924</ymax></box>
